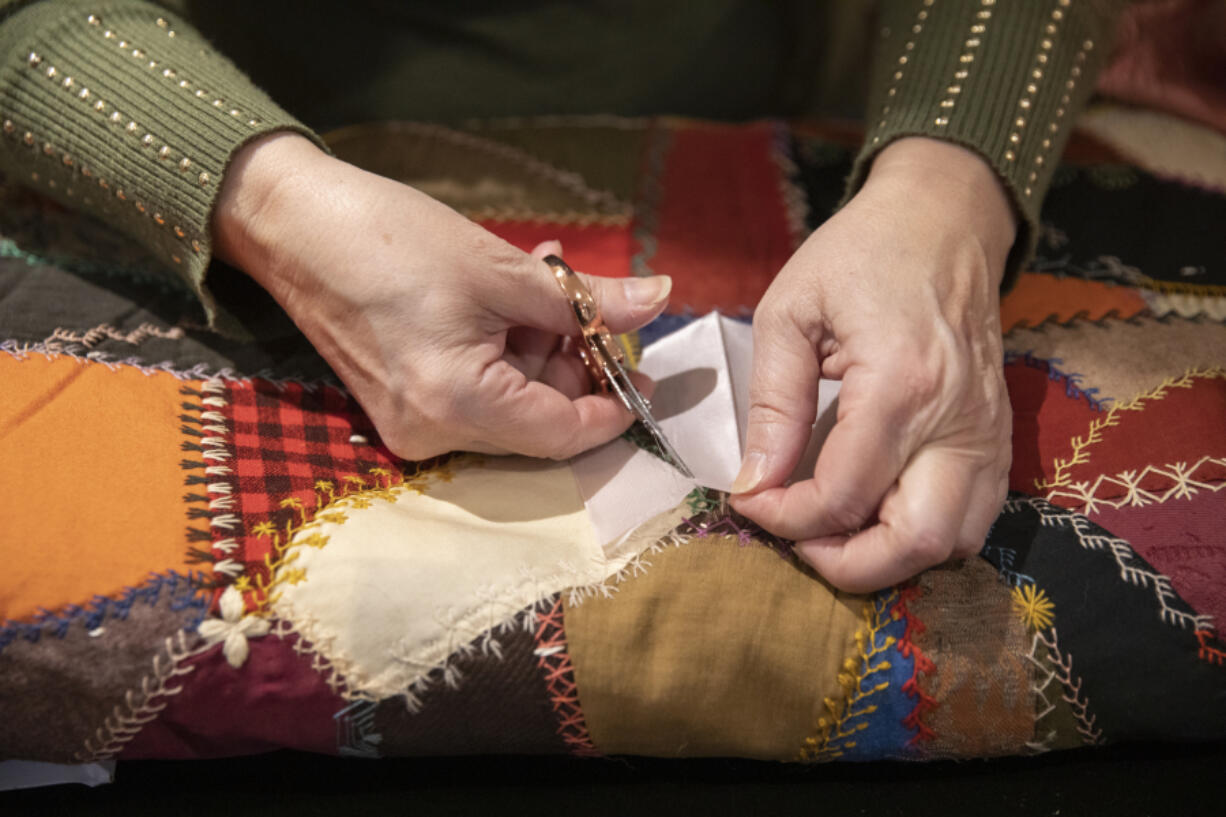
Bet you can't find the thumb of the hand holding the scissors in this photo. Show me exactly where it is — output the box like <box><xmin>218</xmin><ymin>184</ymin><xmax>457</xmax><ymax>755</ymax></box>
<box><xmin>492</xmin><ymin>247</ymin><xmax>673</xmax><ymax>335</ymax></box>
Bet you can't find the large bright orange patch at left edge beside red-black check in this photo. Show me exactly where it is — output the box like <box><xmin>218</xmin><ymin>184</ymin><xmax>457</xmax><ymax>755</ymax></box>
<box><xmin>0</xmin><ymin>355</ymin><xmax>199</xmax><ymax>621</ymax></box>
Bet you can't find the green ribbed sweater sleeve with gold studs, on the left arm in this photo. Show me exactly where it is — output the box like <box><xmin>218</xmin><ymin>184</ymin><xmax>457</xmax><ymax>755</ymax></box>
<box><xmin>0</xmin><ymin>0</ymin><xmax>320</xmax><ymax>334</ymax></box>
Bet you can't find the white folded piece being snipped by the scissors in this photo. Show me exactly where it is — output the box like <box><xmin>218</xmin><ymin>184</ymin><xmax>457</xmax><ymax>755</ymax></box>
<box><xmin>571</xmin><ymin>312</ymin><xmax>840</xmax><ymax>542</ymax></box>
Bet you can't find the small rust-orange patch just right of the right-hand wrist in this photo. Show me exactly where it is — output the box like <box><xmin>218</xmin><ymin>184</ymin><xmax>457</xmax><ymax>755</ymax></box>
<box><xmin>1000</xmin><ymin>272</ymin><xmax>1148</xmax><ymax>331</ymax></box>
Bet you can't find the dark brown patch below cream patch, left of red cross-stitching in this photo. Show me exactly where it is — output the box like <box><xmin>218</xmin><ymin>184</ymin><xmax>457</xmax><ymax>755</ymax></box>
<box><xmin>373</xmin><ymin>600</ymin><xmax>566</xmax><ymax>756</ymax></box>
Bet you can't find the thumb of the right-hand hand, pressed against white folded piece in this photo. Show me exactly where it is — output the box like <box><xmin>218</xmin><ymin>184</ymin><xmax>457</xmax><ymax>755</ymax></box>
<box><xmin>732</xmin><ymin>315</ymin><xmax>820</xmax><ymax>494</ymax></box>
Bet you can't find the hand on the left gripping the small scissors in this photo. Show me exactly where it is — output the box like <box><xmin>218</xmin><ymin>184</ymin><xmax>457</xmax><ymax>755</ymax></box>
<box><xmin>213</xmin><ymin>134</ymin><xmax>671</xmax><ymax>460</ymax></box>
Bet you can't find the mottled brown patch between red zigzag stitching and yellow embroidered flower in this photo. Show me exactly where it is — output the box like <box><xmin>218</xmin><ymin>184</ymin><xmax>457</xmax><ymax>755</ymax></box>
<box><xmin>910</xmin><ymin>558</ymin><xmax>1035</xmax><ymax>757</ymax></box>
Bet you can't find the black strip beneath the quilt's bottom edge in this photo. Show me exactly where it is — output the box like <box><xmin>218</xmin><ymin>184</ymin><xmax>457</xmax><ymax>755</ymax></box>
<box><xmin>0</xmin><ymin>743</ymin><xmax>1226</xmax><ymax>817</ymax></box>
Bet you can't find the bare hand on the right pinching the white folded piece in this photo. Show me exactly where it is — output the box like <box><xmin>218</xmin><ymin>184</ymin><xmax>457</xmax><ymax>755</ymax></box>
<box><xmin>732</xmin><ymin>137</ymin><xmax>1016</xmax><ymax>593</ymax></box>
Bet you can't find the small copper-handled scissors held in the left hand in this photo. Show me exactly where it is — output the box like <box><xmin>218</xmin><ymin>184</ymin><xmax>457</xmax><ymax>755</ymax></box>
<box><xmin>544</xmin><ymin>255</ymin><xmax>694</xmax><ymax>480</ymax></box>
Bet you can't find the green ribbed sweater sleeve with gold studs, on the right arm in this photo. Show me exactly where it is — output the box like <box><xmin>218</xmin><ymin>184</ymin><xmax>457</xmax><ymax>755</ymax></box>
<box><xmin>847</xmin><ymin>0</ymin><xmax>1127</xmax><ymax>286</ymax></box>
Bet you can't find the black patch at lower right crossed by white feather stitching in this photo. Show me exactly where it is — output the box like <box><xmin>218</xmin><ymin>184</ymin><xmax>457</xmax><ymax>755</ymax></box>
<box><xmin>983</xmin><ymin>494</ymin><xmax>1226</xmax><ymax>742</ymax></box>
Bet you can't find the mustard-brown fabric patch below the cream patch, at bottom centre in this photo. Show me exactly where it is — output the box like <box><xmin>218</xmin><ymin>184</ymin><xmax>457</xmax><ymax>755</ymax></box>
<box><xmin>565</xmin><ymin>536</ymin><xmax>863</xmax><ymax>761</ymax></box>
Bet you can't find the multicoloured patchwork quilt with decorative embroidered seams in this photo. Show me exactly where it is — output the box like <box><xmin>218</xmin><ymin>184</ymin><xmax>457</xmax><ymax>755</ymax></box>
<box><xmin>0</xmin><ymin>118</ymin><xmax>1226</xmax><ymax>763</ymax></box>
